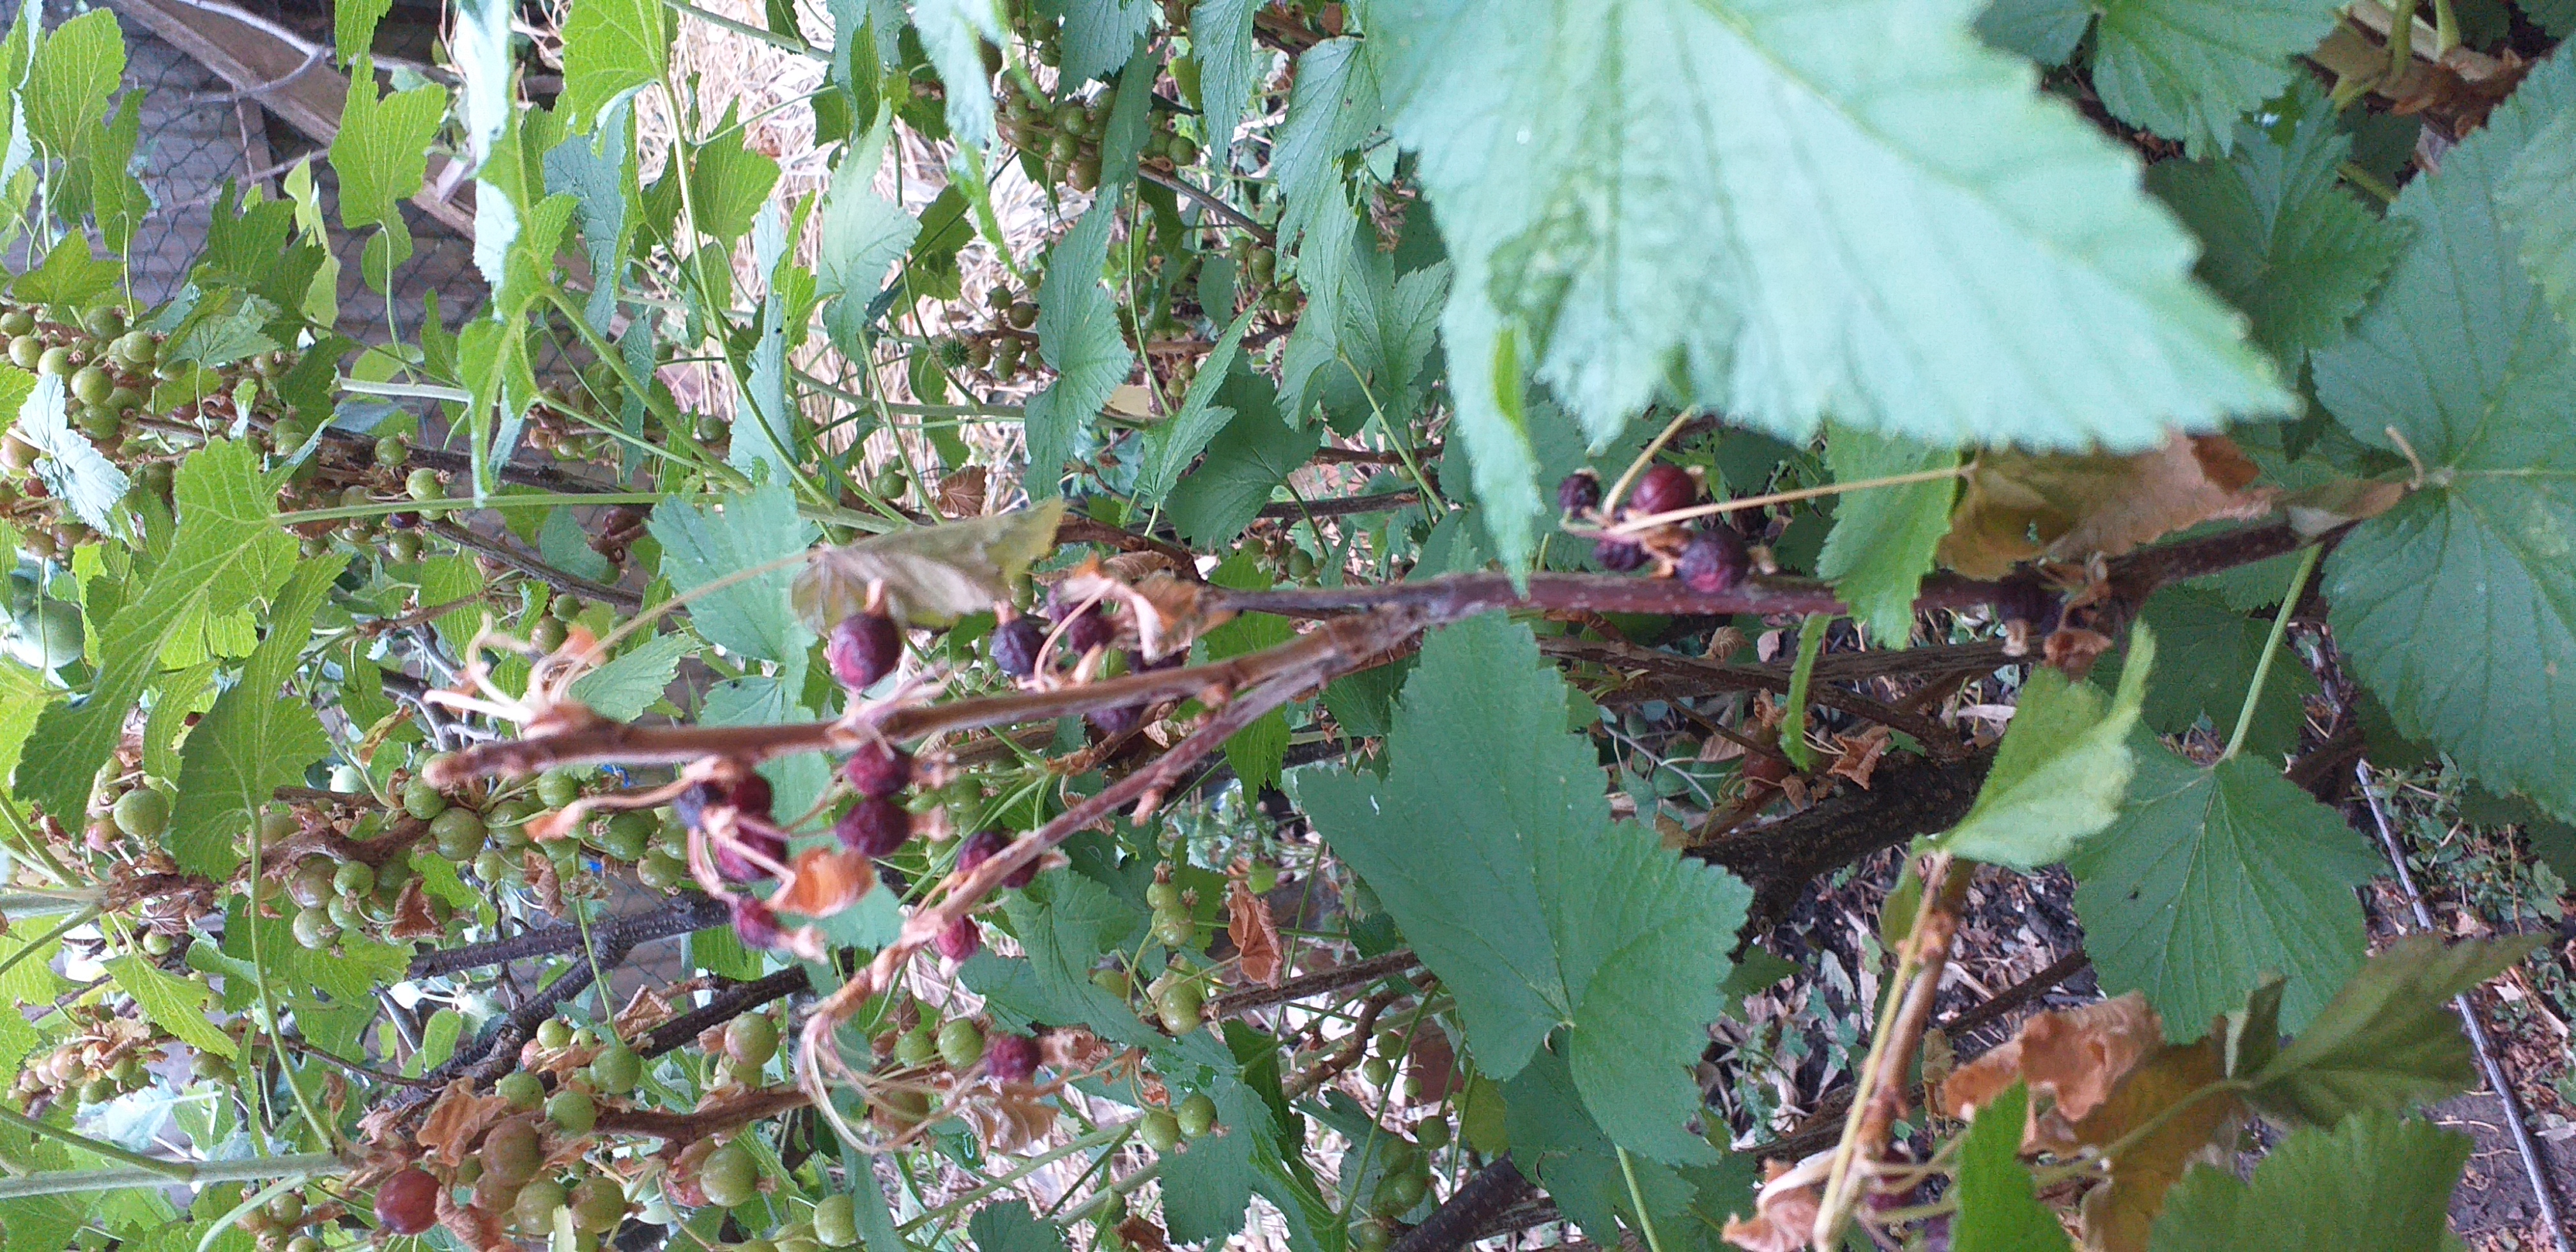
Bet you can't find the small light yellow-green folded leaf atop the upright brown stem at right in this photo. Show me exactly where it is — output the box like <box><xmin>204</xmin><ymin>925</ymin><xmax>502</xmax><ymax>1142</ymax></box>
<box><xmin>1932</xmin><ymin>629</ymin><xmax>2156</xmax><ymax>871</ymax></box>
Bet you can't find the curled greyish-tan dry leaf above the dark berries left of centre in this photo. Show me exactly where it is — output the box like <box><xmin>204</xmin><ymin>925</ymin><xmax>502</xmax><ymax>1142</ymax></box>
<box><xmin>796</xmin><ymin>500</ymin><xmax>1064</xmax><ymax>631</ymax></box>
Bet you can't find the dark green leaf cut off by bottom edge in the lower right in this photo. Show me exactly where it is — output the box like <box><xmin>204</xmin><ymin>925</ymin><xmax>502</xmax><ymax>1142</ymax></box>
<box><xmin>2146</xmin><ymin>1113</ymin><xmax>2471</xmax><ymax>1252</ymax></box>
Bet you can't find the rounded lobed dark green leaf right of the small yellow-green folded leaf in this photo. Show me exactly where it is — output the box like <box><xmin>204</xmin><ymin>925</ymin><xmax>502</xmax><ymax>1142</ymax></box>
<box><xmin>2071</xmin><ymin>737</ymin><xmax>2383</xmax><ymax>1041</ymax></box>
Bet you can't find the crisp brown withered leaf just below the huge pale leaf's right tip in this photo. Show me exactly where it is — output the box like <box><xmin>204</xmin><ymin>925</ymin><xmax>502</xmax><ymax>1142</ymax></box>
<box><xmin>1940</xmin><ymin>436</ymin><xmax>2272</xmax><ymax>577</ymax></box>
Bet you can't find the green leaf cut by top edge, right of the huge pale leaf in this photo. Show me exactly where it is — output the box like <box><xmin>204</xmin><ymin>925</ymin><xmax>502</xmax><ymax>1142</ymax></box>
<box><xmin>2092</xmin><ymin>0</ymin><xmax>2344</xmax><ymax>157</ymax></box>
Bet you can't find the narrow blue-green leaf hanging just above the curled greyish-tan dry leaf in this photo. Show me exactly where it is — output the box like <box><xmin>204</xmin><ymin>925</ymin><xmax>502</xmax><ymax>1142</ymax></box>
<box><xmin>1023</xmin><ymin>199</ymin><xmax>1136</xmax><ymax>500</ymax></box>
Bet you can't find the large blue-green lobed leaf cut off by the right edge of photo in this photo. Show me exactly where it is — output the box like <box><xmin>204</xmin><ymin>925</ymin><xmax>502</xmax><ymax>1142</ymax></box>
<box><xmin>2313</xmin><ymin>57</ymin><xmax>2576</xmax><ymax>814</ymax></box>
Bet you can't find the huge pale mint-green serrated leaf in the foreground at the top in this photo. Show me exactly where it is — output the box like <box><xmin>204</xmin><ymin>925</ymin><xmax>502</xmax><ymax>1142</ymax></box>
<box><xmin>1368</xmin><ymin>0</ymin><xmax>2290</xmax><ymax>561</ymax></box>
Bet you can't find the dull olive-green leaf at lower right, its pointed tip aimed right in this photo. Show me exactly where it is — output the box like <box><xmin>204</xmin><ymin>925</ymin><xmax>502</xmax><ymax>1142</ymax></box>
<box><xmin>2246</xmin><ymin>935</ymin><xmax>2538</xmax><ymax>1126</ymax></box>
